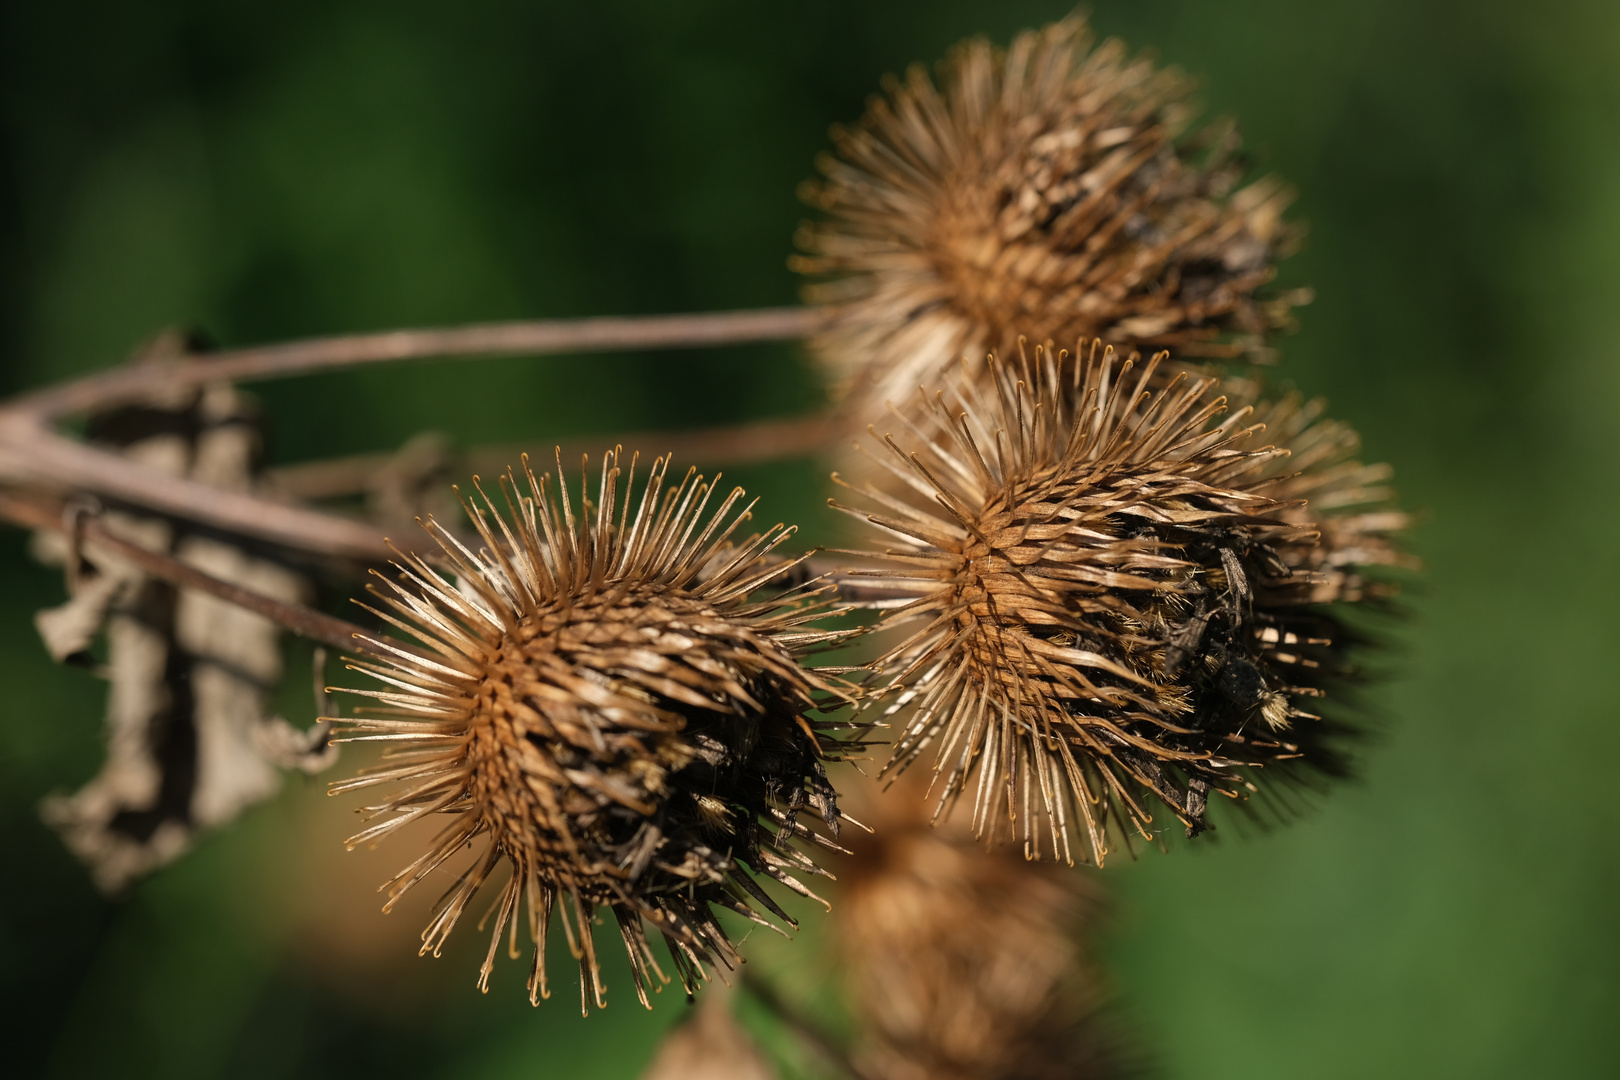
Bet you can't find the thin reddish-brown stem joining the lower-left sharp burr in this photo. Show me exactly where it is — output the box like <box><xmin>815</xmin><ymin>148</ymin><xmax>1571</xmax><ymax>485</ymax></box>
<box><xmin>0</xmin><ymin>491</ymin><xmax>379</xmax><ymax>651</ymax></box>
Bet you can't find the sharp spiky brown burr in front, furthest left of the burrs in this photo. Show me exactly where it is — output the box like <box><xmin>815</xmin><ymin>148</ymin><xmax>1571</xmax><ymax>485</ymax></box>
<box><xmin>334</xmin><ymin>452</ymin><xmax>839</xmax><ymax>1009</ymax></box>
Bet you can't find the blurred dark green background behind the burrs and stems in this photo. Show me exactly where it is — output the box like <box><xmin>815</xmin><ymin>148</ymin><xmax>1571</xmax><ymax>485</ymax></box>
<box><xmin>0</xmin><ymin>0</ymin><xmax>1620</xmax><ymax>1080</ymax></box>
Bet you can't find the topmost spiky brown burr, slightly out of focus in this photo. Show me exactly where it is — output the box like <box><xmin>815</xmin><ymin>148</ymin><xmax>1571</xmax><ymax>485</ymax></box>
<box><xmin>794</xmin><ymin>16</ymin><xmax>1304</xmax><ymax>419</ymax></box>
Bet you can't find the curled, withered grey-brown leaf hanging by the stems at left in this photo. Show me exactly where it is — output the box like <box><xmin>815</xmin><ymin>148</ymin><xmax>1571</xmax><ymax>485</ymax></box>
<box><xmin>34</xmin><ymin>372</ymin><xmax>335</xmax><ymax>892</ymax></box>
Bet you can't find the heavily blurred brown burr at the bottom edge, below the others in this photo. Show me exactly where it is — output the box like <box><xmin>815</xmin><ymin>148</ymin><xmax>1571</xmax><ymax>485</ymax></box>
<box><xmin>833</xmin><ymin>777</ymin><xmax>1131</xmax><ymax>1080</ymax></box>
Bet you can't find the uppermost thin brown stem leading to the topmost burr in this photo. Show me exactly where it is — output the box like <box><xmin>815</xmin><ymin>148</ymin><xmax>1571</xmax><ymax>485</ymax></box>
<box><xmin>5</xmin><ymin>308</ymin><xmax>829</xmax><ymax>421</ymax></box>
